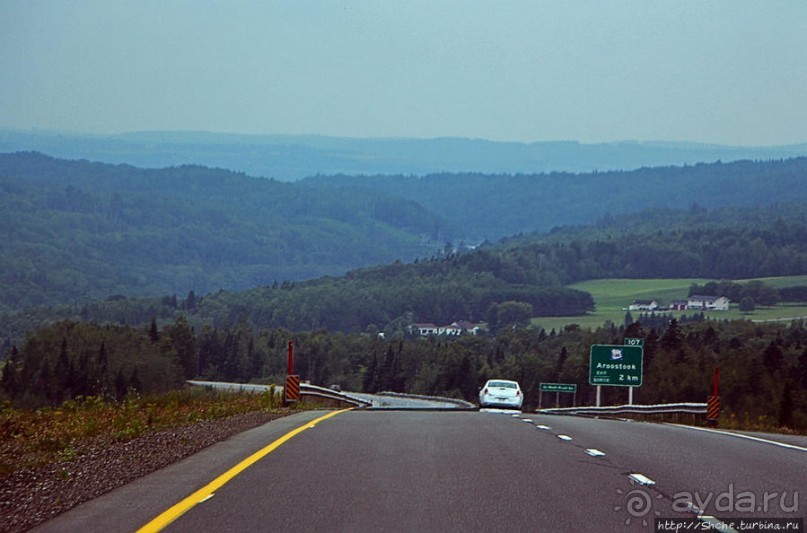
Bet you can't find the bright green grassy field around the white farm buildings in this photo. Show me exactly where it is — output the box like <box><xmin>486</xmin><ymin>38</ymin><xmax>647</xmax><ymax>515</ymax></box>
<box><xmin>532</xmin><ymin>275</ymin><xmax>807</xmax><ymax>331</ymax></box>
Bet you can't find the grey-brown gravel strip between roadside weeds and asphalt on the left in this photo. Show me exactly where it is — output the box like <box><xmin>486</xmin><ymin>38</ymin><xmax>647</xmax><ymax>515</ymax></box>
<box><xmin>0</xmin><ymin>412</ymin><xmax>292</xmax><ymax>532</ymax></box>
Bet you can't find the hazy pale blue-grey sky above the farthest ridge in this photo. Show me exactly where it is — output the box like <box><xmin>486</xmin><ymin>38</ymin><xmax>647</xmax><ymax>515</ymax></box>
<box><xmin>0</xmin><ymin>0</ymin><xmax>807</xmax><ymax>145</ymax></box>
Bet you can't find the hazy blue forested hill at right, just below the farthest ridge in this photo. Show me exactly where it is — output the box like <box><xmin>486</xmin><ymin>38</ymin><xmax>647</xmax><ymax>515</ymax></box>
<box><xmin>303</xmin><ymin>158</ymin><xmax>807</xmax><ymax>240</ymax></box>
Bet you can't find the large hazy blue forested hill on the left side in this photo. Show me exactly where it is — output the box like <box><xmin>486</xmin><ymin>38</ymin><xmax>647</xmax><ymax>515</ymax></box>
<box><xmin>0</xmin><ymin>153</ymin><xmax>440</xmax><ymax>311</ymax></box>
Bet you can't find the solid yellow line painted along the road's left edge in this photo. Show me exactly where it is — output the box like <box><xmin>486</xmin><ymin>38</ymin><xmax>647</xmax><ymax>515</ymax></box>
<box><xmin>137</xmin><ymin>409</ymin><xmax>351</xmax><ymax>533</ymax></box>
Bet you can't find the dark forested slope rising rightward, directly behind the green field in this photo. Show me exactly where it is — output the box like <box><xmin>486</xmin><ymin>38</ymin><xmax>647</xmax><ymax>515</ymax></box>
<box><xmin>0</xmin><ymin>200</ymin><xmax>807</xmax><ymax>344</ymax></box>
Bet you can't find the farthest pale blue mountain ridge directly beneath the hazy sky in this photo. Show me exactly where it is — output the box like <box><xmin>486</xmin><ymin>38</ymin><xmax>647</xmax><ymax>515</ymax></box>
<box><xmin>0</xmin><ymin>129</ymin><xmax>807</xmax><ymax>181</ymax></box>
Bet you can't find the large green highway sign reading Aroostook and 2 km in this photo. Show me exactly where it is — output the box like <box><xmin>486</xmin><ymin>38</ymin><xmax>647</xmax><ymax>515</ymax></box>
<box><xmin>588</xmin><ymin>344</ymin><xmax>644</xmax><ymax>387</ymax></box>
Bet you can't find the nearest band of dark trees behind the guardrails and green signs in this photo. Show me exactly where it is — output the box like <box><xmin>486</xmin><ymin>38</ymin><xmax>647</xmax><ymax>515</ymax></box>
<box><xmin>0</xmin><ymin>318</ymin><xmax>807</xmax><ymax>430</ymax></box>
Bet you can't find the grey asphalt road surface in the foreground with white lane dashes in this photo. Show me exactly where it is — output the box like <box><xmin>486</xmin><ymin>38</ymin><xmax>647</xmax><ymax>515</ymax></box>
<box><xmin>36</xmin><ymin>411</ymin><xmax>807</xmax><ymax>532</ymax></box>
